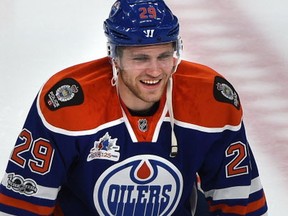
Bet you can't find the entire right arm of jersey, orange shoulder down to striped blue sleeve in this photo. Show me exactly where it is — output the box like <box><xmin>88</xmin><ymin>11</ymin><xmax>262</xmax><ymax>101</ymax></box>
<box><xmin>174</xmin><ymin>61</ymin><xmax>267</xmax><ymax>216</ymax></box>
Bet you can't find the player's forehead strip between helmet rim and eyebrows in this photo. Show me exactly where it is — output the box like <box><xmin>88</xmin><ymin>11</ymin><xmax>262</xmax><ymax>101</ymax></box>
<box><xmin>123</xmin><ymin>43</ymin><xmax>173</xmax><ymax>54</ymax></box>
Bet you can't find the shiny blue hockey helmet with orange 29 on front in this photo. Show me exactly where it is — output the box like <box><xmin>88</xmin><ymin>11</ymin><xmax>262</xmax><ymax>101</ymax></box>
<box><xmin>104</xmin><ymin>0</ymin><xmax>179</xmax><ymax>57</ymax></box>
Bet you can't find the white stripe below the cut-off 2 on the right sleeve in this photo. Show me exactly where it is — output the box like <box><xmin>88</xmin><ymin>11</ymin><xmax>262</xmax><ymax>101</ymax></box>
<box><xmin>205</xmin><ymin>177</ymin><xmax>262</xmax><ymax>201</ymax></box>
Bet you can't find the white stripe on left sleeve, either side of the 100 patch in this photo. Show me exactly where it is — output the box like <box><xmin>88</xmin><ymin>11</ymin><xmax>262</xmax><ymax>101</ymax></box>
<box><xmin>2</xmin><ymin>173</ymin><xmax>61</xmax><ymax>200</ymax></box>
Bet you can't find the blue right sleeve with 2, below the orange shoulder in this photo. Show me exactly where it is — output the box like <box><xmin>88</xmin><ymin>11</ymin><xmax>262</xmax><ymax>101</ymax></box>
<box><xmin>199</xmin><ymin>111</ymin><xmax>267</xmax><ymax>216</ymax></box>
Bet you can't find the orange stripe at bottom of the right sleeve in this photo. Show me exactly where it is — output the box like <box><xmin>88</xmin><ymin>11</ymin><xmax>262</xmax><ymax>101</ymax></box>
<box><xmin>209</xmin><ymin>193</ymin><xmax>266</xmax><ymax>215</ymax></box>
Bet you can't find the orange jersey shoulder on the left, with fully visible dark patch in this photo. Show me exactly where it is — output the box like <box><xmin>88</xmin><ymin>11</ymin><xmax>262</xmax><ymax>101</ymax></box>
<box><xmin>37</xmin><ymin>58</ymin><xmax>121</xmax><ymax>131</ymax></box>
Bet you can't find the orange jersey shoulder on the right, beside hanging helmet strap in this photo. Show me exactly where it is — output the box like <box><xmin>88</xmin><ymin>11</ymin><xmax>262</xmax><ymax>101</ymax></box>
<box><xmin>173</xmin><ymin>61</ymin><xmax>243</xmax><ymax>127</ymax></box>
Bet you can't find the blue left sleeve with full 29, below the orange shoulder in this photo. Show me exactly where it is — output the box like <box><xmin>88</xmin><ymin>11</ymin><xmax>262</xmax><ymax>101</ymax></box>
<box><xmin>0</xmin><ymin>95</ymin><xmax>77</xmax><ymax>216</ymax></box>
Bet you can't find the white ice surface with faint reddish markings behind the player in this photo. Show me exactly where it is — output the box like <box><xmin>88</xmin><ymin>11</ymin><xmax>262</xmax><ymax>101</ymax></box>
<box><xmin>0</xmin><ymin>0</ymin><xmax>288</xmax><ymax>213</ymax></box>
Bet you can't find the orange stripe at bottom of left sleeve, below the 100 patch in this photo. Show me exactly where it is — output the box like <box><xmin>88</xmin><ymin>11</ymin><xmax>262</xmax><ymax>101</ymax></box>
<box><xmin>0</xmin><ymin>194</ymin><xmax>54</xmax><ymax>215</ymax></box>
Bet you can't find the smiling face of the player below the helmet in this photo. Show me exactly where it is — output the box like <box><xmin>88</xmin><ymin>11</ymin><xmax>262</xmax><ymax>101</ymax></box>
<box><xmin>116</xmin><ymin>43</ymin><xmax>176</xmax><ymax>110</ymax></box>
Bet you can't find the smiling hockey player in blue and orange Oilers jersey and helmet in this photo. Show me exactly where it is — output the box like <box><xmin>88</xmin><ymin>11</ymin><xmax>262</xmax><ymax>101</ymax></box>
<box><xmin>0</xmin><ymin>0</ymin><xmax>267</xmax><ymax>216</ymax></box>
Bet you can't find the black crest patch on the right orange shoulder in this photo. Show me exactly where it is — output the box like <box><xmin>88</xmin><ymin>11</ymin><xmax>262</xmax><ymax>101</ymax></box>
<box><xmin>213</xmin><ymin>76</ymin><xmax>241</xmax><ymax>110</ymax></box>
